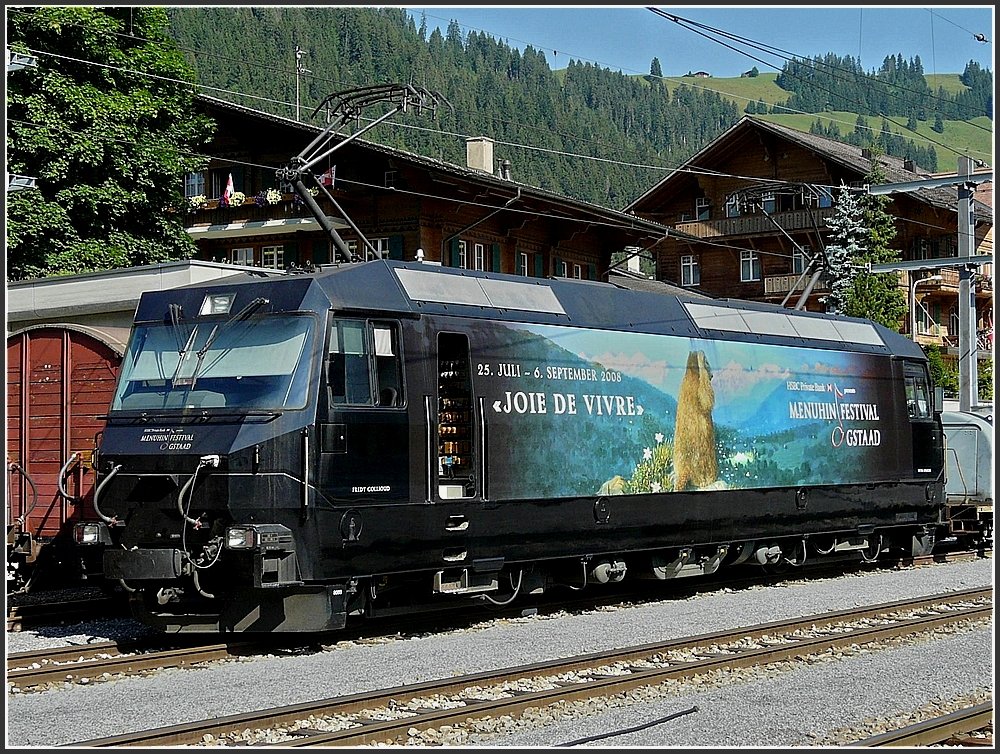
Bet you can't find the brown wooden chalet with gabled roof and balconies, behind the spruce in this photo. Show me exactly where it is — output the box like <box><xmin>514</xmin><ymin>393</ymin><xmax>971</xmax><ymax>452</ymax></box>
<box><xmin>626</xmin><ymin>116</ymin><xmax>993</xmax><ymax>347</ymax></box>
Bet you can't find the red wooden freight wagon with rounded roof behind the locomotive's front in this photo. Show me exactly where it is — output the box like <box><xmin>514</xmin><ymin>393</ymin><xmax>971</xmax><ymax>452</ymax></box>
<box><xmin>7</xmin><ymin>324</ymin><xmax>128</xmax><ymax>593</ymax></box>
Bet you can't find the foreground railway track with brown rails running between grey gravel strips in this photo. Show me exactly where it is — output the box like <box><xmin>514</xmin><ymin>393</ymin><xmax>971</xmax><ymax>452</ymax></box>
<box><xmin>74</xmin><ymin>588</ymin><xmax>993</xmax><ymax>748</ymax></box>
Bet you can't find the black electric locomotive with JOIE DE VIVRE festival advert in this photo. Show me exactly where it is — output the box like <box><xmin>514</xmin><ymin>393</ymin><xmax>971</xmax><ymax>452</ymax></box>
<box><xmin>88</xmin><ymin>259</ymin><xmax>946</xmax><ymax>633</ymax></box>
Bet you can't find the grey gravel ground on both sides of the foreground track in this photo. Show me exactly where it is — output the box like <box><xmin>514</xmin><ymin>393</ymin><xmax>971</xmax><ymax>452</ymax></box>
<box><xmin>7</xmin><ymin>558</ymin><xmax>994</xmax><ymax>747</ymax></box>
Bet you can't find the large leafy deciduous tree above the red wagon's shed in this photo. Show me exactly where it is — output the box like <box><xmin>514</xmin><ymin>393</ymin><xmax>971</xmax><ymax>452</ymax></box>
<box><xmin>7</xmin><ymin>6</ymin><xmax>211</xmax><ymax>279</ymax></box>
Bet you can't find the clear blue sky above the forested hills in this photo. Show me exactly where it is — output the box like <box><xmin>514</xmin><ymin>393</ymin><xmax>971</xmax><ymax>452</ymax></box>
<box><xmin>405</xmin><ymin>4</ymin><xmax>994</xmax><ymax>78</ymax></box>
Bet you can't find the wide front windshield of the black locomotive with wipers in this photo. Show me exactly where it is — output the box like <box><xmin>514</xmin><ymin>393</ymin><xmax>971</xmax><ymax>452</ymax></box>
<box><xmin>111</xmin><ymin>315</ymin><xmax>314</xmax><ymax>411</ymax></box>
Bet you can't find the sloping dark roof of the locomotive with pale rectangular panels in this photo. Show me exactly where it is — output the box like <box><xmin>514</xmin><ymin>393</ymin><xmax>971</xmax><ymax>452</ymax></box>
<box><xmin>145</xmin><ymin>260</ymin><xmax>924</xmax><ymax>359</ymax></box>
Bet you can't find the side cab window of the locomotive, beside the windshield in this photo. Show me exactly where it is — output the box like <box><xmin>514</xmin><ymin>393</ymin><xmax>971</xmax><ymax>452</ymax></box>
<box><xmin>327</xmin><ymin>319</ymin><xmax>403</xmax><ymax>406</ymax></box>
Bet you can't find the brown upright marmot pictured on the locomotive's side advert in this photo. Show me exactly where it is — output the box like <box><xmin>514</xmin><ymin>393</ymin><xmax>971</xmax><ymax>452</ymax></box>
<box><xmin>673</xmin><ymin>351</ymin><xmax>719</xmax><ymax>490</ymax></box>
